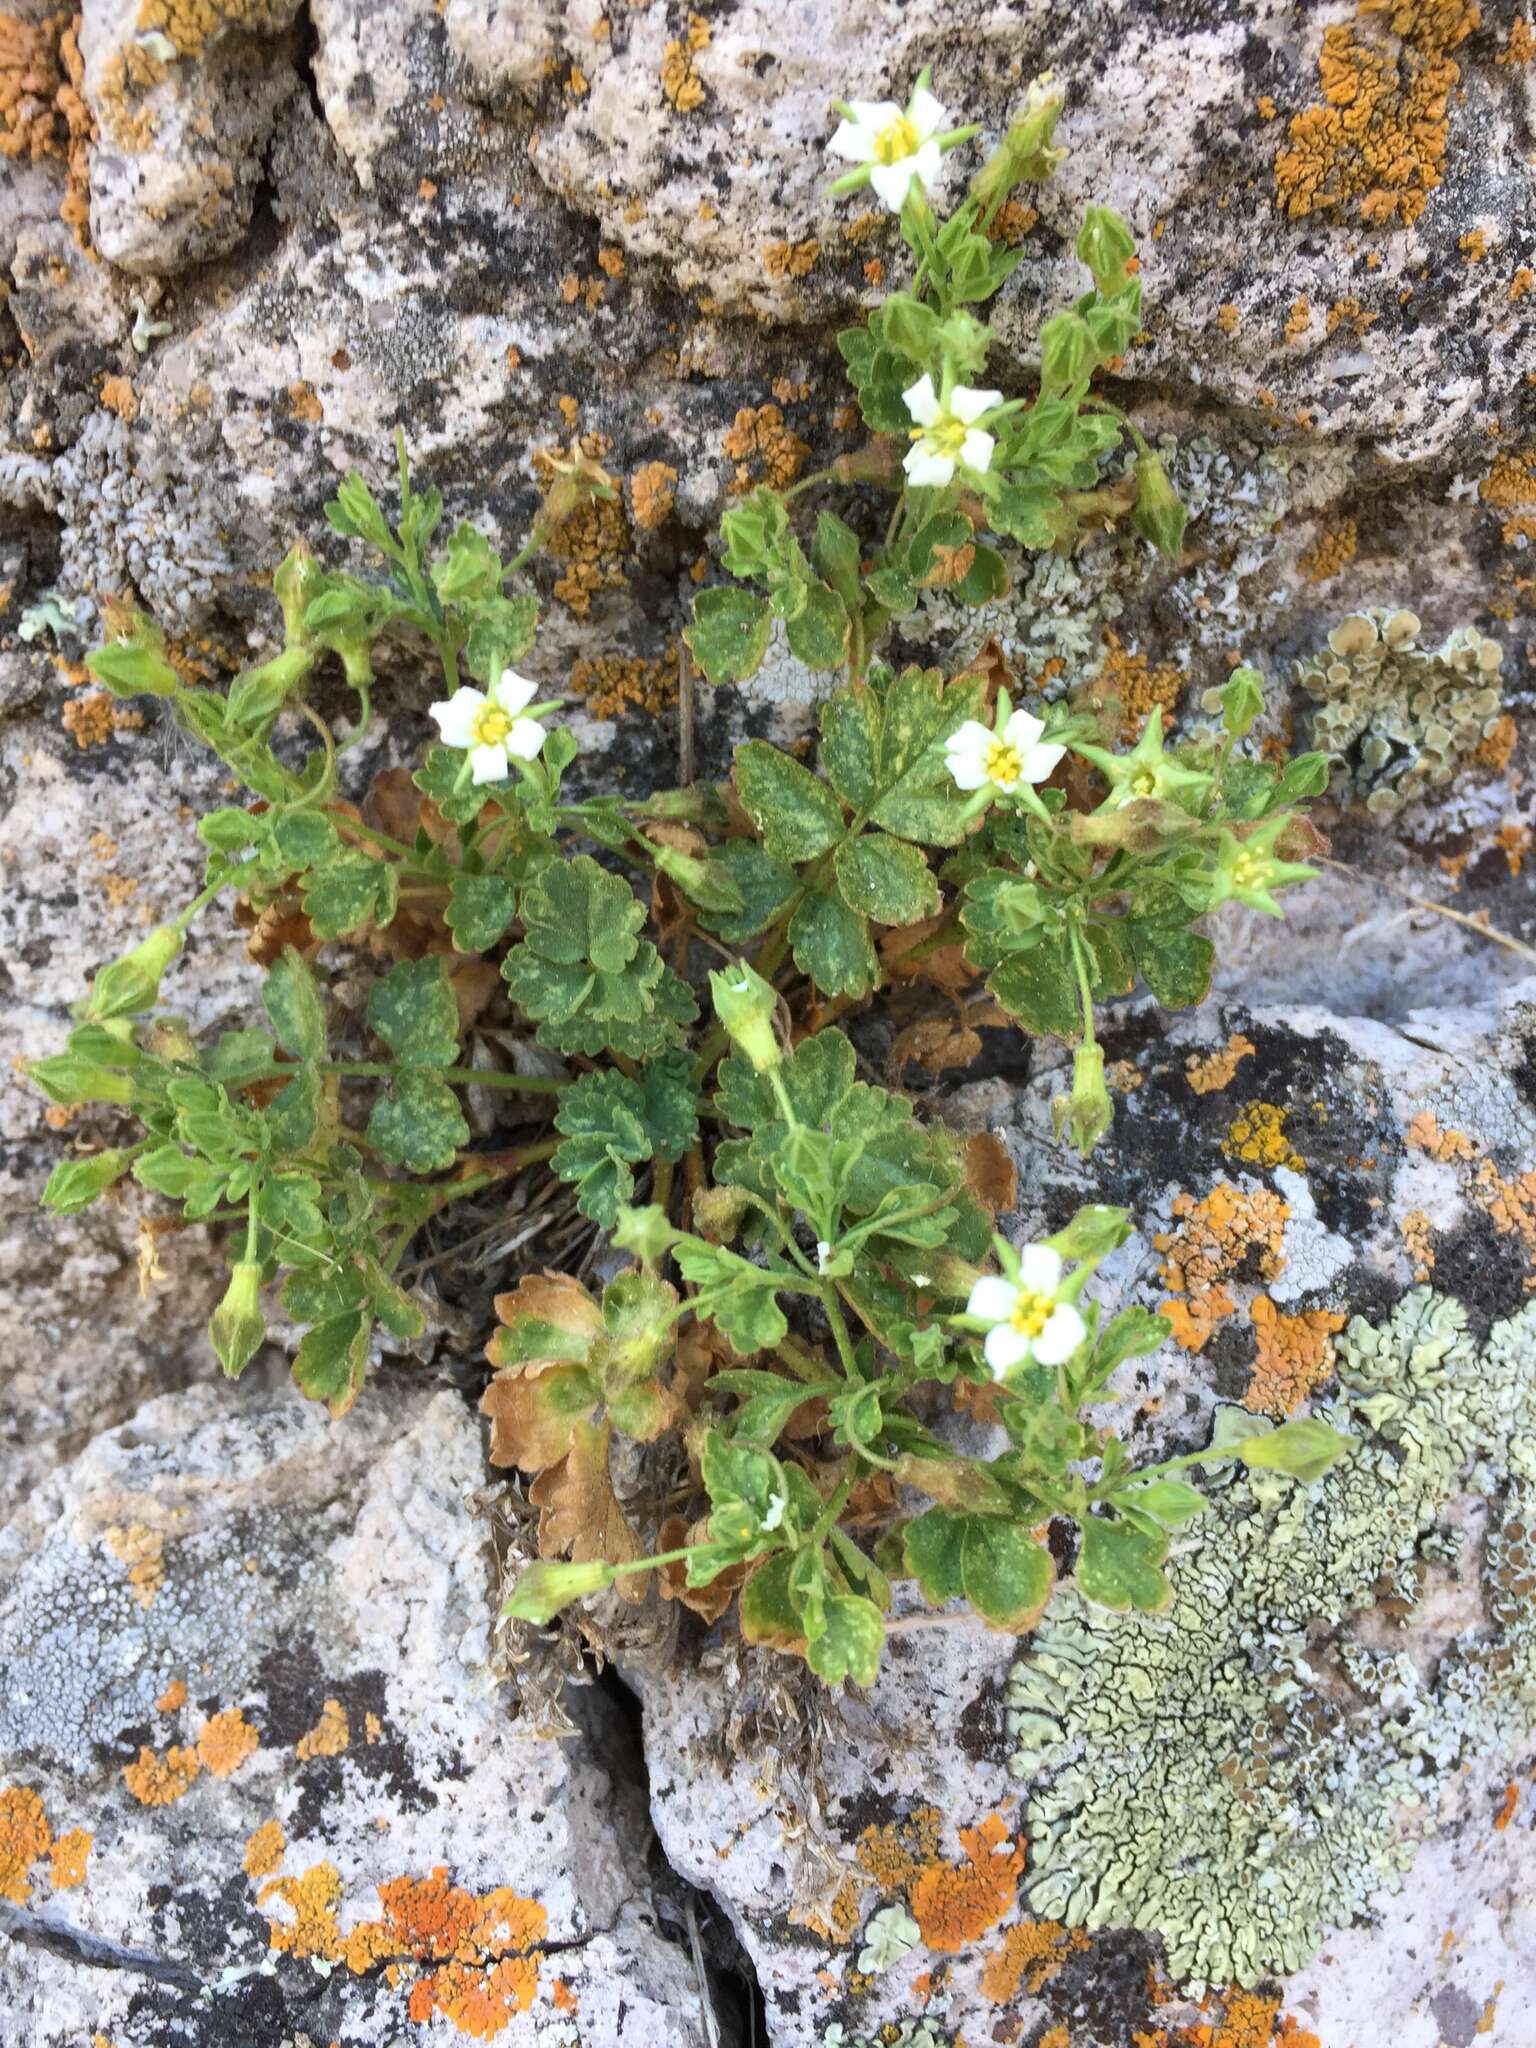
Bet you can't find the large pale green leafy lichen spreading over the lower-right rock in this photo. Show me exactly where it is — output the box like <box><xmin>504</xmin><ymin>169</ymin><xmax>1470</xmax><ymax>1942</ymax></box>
<box><xmin>1010</xmin><ymin>1288</ymin><xmax>1536</xmax><ymax>1985</ymax></box>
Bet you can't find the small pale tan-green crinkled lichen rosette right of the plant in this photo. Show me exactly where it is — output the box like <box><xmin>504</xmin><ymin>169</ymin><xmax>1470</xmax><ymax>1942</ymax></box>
<box><xmin>1296</xmin><ymin>610</ymin><xmax>1503</xmax><ymax>815</ymax></box>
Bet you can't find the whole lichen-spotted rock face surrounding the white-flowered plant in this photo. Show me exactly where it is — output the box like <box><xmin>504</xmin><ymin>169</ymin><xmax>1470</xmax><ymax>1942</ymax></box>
<box><xmin>0</xmin><ymin>0</ymin><xmax>1536</xmax><ymax>2048</ymax></box>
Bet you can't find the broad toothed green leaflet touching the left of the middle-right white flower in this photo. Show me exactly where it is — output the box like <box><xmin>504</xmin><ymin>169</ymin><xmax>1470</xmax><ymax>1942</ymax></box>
<box><xmin>819</xmin><ymin>668</ymin><xmax>985</xmax><ymax>839</ymax></box>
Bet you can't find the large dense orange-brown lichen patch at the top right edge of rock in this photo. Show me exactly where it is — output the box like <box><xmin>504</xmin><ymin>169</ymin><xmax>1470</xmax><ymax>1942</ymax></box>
<box><xmin>1274</xmin><ymin>0</ymin><xmax>1481</xmax><ymax>227</ymax></box>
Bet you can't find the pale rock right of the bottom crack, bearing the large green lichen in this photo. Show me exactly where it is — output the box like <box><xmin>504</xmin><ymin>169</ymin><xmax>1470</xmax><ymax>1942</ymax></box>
<box><xmin>635</xmin><ymin>981</ymin><xmax>1536</xmax><ymax>2048</ymax></box>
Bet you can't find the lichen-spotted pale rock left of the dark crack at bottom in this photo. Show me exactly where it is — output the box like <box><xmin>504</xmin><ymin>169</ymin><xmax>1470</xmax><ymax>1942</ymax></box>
<box><xmin>0</xmin><ymin>1380</ymin><xmax>705</xmax><ymax>2048</ymax></box>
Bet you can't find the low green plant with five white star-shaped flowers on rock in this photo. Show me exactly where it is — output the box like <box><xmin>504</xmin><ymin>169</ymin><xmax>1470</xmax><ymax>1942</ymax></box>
<box><xmin>31</xmin><ymin>82</ymin><xmax>1339</xmax><ymax>1683</ymax></box>
